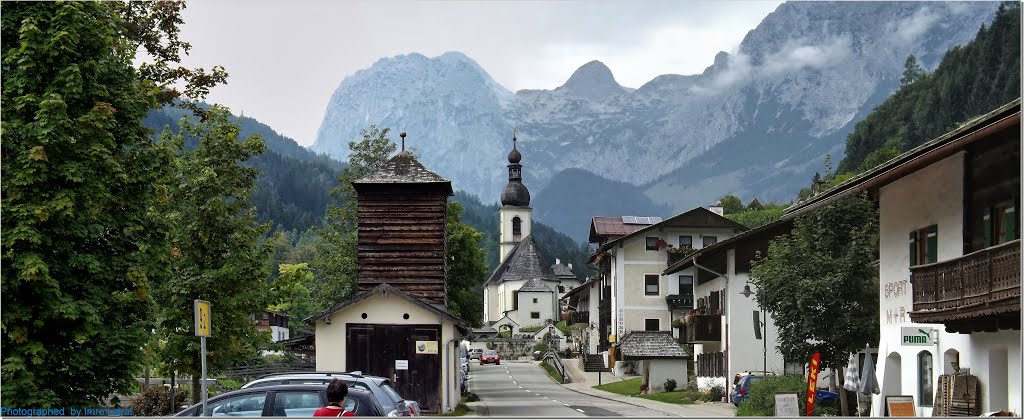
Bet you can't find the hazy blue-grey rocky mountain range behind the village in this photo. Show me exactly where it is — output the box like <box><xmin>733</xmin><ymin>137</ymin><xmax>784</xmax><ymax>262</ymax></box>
<box><xmin>311</xmin><ymin>2</ymin><xmax>998</xmax><ymax>240</ymax></box>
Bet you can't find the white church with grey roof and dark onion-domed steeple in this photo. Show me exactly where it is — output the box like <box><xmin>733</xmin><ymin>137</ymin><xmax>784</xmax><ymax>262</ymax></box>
<box><xmin>483</xmin><ymin>135</ymin><xmax>581</xmax><ymax>334</ymax></box>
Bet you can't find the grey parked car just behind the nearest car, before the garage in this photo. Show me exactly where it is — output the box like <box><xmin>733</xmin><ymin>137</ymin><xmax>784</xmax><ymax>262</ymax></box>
<box><xmin>242</xmin><ymin>372</ymin><xmax>422</xmax><ymax>417</ymax></box>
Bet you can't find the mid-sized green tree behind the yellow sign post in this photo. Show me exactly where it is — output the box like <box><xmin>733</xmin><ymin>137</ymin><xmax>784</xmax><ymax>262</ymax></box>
<box><xmin>155</xmin><ymin>106</ymin><xmax>272</xmax><ymax>401</ymax></box>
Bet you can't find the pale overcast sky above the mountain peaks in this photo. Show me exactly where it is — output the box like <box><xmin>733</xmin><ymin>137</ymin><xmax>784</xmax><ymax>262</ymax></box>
<box><xmin>181</xmin><ymin>0</ymin><xmax>781</xmax><ymax>146</ymax></box>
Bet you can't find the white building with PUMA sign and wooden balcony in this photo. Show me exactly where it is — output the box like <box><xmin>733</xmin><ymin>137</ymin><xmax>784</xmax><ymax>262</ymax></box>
<box><xmin>788</xmin><ymin>99</ymin><xmax>1022</xmax><ymax>416</ymax></box>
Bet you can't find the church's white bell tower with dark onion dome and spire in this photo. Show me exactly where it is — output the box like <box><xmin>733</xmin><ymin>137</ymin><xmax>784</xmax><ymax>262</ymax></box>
<box><xmin>499</xmin><ymin>129</ymin><xmax>532</xmax><ymax>261</ymax></box>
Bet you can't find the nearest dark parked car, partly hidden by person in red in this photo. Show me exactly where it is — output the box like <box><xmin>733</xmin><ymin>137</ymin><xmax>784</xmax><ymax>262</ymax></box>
<box><xmin>174</xmin><ymin>384</ymin><xmax>386</xmax><ymax>417</ymax></box>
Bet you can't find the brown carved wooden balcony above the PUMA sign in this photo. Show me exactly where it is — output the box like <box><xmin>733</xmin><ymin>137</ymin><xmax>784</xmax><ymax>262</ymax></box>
<box><xmin>910</xmin><ymin>240</ymin><xmax>1021</xmax><ymax>333</ymax></box>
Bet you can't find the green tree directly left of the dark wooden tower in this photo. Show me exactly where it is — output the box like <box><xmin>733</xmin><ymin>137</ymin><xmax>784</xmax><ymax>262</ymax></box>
<box><xmin>311</xmin><ymin>125</ymin><xmax>395</xmax><ymax>308</ymax></box>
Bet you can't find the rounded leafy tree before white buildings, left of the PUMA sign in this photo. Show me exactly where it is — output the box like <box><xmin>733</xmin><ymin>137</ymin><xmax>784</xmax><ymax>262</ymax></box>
<box><xmin>751</xmin><ymin>191</ymin><xmax>879</xmax><ymax>368</ymax></box>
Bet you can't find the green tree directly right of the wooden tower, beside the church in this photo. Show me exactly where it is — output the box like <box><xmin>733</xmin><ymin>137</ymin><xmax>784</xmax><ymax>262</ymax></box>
<box><xmin>444</xmin><ymin>202</ymin><xmax>487</xmax><ymax>327</ymax></box>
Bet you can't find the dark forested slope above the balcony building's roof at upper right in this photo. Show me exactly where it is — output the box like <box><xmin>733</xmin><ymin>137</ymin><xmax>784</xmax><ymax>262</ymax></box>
<box><xmin>837</xmin><ymin>2</ymin><xmax>1021</xmax><ymax>173</ymax></box>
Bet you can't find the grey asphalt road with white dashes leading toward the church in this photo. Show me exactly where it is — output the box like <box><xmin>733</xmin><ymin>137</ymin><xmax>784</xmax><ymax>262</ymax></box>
<box><xmin>469</xmin><ymin>361</ymin><xmax>670</xmax><ymax>417</ymax></box>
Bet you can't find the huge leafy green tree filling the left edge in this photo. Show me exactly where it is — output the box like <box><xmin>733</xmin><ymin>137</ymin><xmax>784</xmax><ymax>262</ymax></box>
<box><xmin>0</xmin><ymin>2</ymin><xmax>225</xmax><ymax>407</ymax></box>
